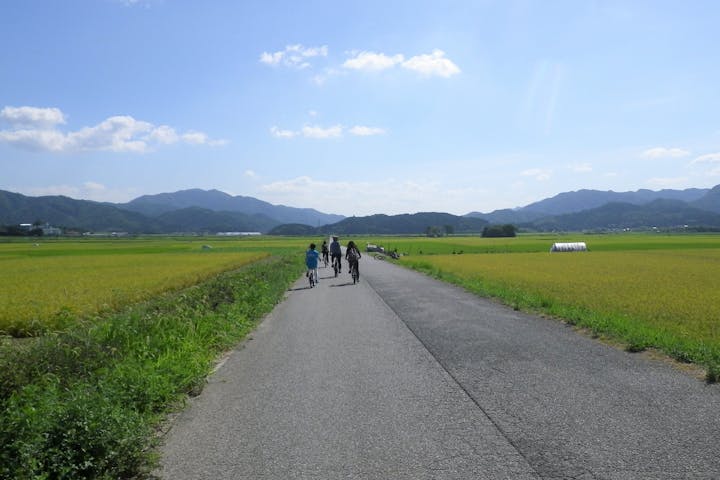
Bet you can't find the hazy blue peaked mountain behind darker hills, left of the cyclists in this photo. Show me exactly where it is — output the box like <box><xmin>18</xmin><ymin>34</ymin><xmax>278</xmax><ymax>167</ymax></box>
<box><xmin>117</xmin><ymin>189</ymin><xmax>345</xmax><ymax>227</ymax></box>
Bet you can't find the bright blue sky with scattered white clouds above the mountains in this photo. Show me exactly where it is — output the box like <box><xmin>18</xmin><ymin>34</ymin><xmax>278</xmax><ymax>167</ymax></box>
<box><xmin>0</xmin><ymin>0</ymin><xmax>720</xmax><ymax>216</ymax></box>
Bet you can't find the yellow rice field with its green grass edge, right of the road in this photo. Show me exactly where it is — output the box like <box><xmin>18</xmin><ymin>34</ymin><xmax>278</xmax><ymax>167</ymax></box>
<box><xmin>402</xmin><ymin>249</ymin><xmax>720</xmax><ymax>382</ymax></box>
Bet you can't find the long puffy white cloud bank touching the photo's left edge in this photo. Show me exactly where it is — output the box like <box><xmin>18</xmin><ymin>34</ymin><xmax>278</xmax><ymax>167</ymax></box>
<box><xmin>0</xmin><ymin>107</ymin><xmax>225</xmax><ymax>153</ymax></box>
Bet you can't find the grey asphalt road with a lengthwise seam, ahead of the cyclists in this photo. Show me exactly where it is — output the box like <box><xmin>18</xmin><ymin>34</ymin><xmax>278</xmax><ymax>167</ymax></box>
<box><xmin>158</xmin><ymin>255</ymin><xmax>720</xmax><ymax>479</ymax></box>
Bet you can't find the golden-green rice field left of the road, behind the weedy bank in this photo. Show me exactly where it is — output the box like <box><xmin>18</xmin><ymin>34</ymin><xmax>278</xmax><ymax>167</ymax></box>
<box><xmin>0</xmin><ymin>240</ymin><xmax>268</xmax><ymax>335</ymax></box>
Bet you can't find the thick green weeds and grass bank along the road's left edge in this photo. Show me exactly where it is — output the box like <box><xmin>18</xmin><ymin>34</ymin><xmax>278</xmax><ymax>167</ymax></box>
<box><xmin>0</xmin><ymin>253</ymin><xmax>302</xmax><ymax>479</ymax></box>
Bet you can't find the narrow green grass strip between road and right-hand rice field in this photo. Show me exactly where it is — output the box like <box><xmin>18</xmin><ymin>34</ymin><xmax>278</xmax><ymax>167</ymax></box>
<box><xmin>402</xmin><ymin>261</ymin><xmax>720</xmax><ymax>383</ymax></box>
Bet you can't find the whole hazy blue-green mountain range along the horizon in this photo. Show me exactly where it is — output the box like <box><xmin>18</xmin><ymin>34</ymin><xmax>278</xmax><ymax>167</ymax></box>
<box><xmin>0</xmin><ymin>185</ymin><xmax>720</xmax><ymax>235</ymax></box>
